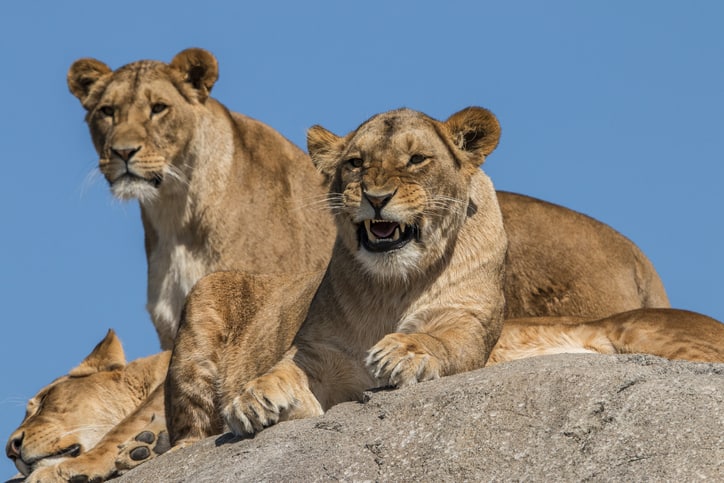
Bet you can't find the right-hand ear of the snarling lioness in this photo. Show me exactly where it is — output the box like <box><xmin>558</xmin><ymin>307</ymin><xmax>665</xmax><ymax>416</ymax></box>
<box><xmin>444</xmin><ymin>107</ymin><xmax>500</xmax><ymax>166</ymax></box>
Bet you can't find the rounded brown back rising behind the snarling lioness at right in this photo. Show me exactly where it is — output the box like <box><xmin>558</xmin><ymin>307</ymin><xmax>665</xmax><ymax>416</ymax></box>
<box><xmin>498</xmin><ymin>191</ymin><xmax>669</xmax><ymax>319</ymax></box>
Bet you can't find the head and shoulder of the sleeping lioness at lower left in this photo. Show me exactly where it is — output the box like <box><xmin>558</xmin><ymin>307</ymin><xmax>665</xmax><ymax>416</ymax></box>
<box><xmin>6</xmin><ymin>331</ymin><xmax>171</xmax><ymax>482</ymax></box>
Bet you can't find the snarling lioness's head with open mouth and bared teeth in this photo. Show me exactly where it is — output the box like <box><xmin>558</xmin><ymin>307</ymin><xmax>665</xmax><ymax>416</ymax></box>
<box><xmin>307</xmin><ymin>107</ymin><xmax>500</xmax><ymax>279</ymax></box>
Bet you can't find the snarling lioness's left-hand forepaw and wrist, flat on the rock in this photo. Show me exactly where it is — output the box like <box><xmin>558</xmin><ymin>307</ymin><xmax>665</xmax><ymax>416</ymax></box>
<box><xmin>222</xmin><ymin>348</ymin><xmax>324</xmax><ymax>436</ymax></box>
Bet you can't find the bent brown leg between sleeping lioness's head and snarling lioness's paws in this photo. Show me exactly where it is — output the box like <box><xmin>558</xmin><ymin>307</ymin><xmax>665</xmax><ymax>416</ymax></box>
<box><xmin>166</xmin><ymin>272</ymin><xmax>323</xmax><ymax>446</ymax></box>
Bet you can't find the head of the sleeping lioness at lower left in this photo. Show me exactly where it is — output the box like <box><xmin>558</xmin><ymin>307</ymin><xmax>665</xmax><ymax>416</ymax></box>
<box><xmin>5</xmin><ymin>331</ymin><xmax>138</xmax><ymax>476</ymax></box>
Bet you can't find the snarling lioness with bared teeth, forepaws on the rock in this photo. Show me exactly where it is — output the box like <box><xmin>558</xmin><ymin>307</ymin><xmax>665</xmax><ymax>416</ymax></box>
<box><xmin>166</xmin><ymin>108</ymin><xmax>684</xmax><ymax>444</ymax></box>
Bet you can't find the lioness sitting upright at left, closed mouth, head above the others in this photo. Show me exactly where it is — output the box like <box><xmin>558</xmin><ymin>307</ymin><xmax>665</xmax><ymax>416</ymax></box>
<box><xmin>68</xmin><ymin>49</ymin><xmax>334</xmax><ymax>349</ymax></box>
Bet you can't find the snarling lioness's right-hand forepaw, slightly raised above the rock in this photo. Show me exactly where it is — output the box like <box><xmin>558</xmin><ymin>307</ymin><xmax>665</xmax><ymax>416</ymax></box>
<box><xmin>365</xmin><ymin>333</ymin><xmax>442</xmax><ymax>387</ymax></box>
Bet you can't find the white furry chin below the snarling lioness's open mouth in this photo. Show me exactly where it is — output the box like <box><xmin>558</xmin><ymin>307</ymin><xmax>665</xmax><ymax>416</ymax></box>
<box><xmin>355</xmin><ymin>243</ymin><xmax>423</xmax><ymax>282</ymax></box>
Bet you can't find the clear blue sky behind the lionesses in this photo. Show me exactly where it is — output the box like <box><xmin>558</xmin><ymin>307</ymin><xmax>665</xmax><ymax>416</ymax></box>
<box><xmin>0</xmin><ymin>0</ymin><xmax>724</xmax><ymax>477</ymax></box>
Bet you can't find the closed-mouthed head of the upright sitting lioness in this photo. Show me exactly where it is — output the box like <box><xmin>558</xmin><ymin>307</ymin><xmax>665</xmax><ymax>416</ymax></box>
<box><xmin>68</xmin><ymin>49</ymin><xmax>218</xmax><ymax>202</ymax></box>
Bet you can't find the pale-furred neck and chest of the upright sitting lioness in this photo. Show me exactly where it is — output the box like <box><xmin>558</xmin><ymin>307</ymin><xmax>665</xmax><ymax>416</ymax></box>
<box><xmin>141</xmin><ymin>99</ymin><xmax>235</xmax><ymax>349</ymax></box>
